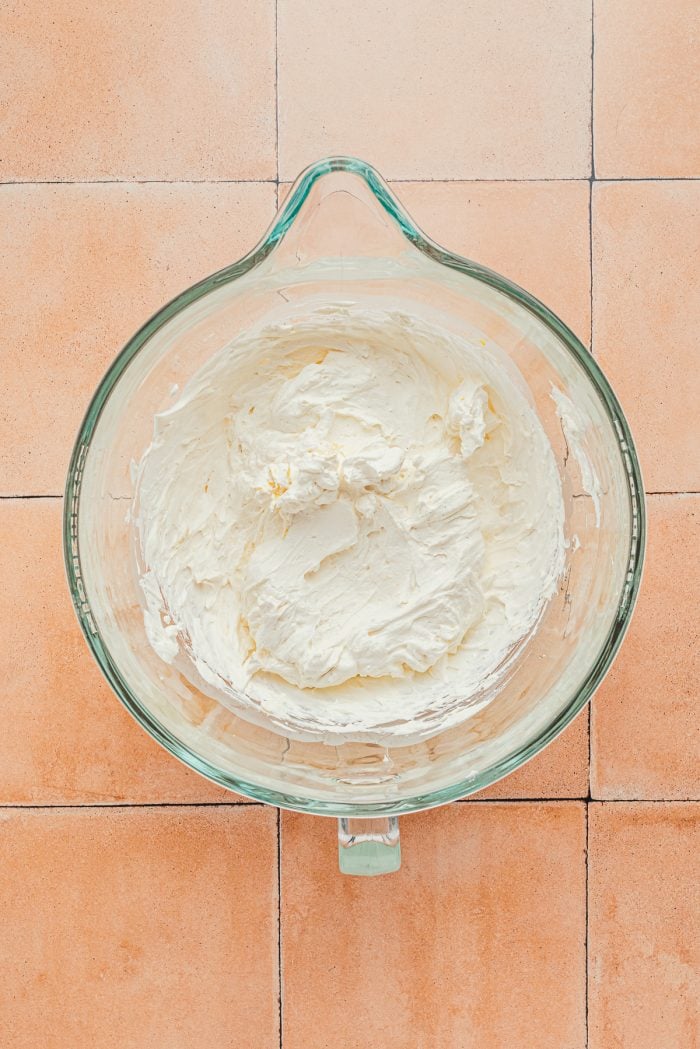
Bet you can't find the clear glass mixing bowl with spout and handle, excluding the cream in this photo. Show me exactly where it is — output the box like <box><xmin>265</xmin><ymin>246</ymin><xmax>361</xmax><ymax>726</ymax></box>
<box><xmin>64</xmin><ymin>157</ymin><xmax>644</xmax><ymax>873</ymax></box>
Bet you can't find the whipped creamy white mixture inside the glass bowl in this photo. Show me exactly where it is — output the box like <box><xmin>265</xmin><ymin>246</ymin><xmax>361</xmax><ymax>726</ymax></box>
<box><xmin>134</xmin><ymin>307</ymin><xmax>565</xmax><ymax>744</ymax></box>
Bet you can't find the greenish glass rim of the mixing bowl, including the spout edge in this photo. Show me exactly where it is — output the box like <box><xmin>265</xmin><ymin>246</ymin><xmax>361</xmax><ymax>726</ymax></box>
<box><xmin>63</xmin><ymin>156</ymin><xmax>646</xmax><ymax>816</ymax></box>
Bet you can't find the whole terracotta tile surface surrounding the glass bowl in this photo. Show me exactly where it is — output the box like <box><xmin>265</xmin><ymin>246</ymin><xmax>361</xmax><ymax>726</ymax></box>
<box><xmin>0</xmin><ymin>0</ymin><xmax>700</xmax><ymax>1049</ymax></box>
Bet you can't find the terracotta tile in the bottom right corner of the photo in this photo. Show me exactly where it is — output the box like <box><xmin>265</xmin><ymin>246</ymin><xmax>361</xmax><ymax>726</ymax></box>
<box><xmin>589</xmin><ymin>802</ymin><xmax>700</xmax><ymax>1049</ymax></box>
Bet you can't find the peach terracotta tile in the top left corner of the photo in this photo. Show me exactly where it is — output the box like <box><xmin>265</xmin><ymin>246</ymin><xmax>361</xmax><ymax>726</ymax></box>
<box><xmin>0</xmin><ymin>0</ymin><xmax>276</xmax><ymax>181</ymax></box>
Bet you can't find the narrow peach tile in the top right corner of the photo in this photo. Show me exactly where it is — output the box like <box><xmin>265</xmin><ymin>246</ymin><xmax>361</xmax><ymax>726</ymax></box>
<box><xmin>594</xmin><ymin>0</ymin><xmax>700</xmax><ymax>178</ymax></box>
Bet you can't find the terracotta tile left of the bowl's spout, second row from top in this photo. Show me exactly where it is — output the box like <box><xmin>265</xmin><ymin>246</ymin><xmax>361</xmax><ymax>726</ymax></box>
<box><xmin>0</xmin><ymin>185</ymin><xmax>275</xmax><ymax>495</ymax></box>
